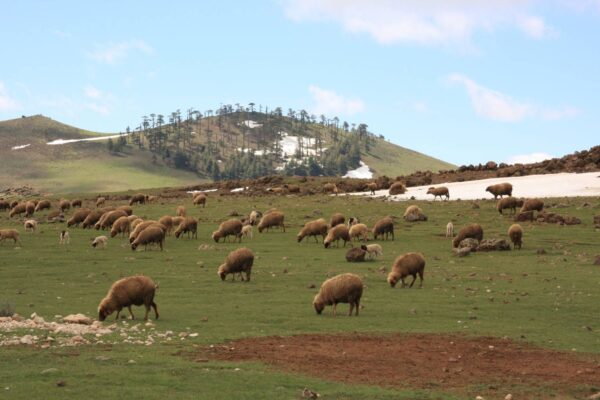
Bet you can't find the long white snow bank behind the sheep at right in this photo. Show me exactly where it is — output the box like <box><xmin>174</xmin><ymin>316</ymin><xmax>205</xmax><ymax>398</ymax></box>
<box><xmin>351</xmin><ymin>172</ymin><xmax>600</xmax><ymax>201</ymax></box>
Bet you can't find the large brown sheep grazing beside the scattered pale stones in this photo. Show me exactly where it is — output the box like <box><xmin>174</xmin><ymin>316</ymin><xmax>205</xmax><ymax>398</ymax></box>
<box><xmin>98</xmin><ymin>275</ymin><xmax>158</xmax><ymax>321</ymax></box>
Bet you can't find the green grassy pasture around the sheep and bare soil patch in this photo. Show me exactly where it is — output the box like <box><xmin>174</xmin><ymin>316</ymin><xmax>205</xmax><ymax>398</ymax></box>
<box><xmin>0</xmin><ymin>192</ymin><xmax>600</xmax><ymax>399</ymax></box>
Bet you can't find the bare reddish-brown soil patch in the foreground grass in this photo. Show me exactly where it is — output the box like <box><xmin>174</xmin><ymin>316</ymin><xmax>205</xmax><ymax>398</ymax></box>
<box><xmin>197</xmin><ymin>334</ymin><xmax>600</xmax><ymax>398</ymax></box>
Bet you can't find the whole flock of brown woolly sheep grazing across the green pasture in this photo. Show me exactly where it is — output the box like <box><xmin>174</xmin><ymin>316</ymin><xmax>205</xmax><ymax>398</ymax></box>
<box><xmin>0</xmin><ymin>183</ymin><xmax>543</xmax><ymax>321</ymax></box>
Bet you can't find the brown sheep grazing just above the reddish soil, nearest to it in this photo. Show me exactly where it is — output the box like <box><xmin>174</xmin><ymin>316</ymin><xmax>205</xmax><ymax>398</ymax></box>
<box><xmin>313</xmin><ymin>274</ymin><xmax>363</xmax><ymax>317</ymax></box>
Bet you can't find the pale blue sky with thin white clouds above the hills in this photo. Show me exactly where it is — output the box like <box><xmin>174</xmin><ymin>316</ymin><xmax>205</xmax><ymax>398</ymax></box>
<box><xmin>0</xmin><ymin>0</ymin><xmax>600</xmax><ymax>164</ymax></box>
